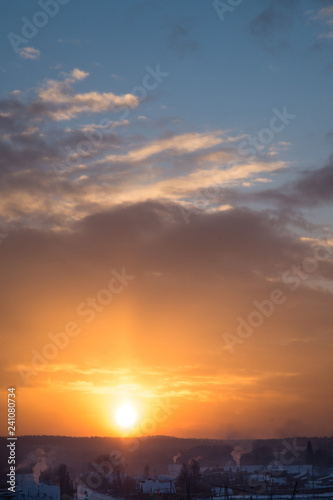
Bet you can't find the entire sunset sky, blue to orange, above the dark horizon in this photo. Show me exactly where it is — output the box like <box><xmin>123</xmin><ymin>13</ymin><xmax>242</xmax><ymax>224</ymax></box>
<box><xmin>0</xmin><ymin>0</ymin><xmax>333</xmax><ymax>439</ymax></box>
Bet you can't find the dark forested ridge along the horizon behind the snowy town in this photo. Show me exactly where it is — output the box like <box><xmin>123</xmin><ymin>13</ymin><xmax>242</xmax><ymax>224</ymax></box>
<box><xmin>0</xmin><ymin>436</ymin><xmax>333</xmax><ymax>479</ymax></box>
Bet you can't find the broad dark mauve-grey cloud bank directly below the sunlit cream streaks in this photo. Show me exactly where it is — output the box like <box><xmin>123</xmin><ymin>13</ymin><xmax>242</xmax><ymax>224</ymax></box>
<box><xmin>1</xmin><ymin>201</ymin><xmax>330</xmax><ymax>292</ymax></box>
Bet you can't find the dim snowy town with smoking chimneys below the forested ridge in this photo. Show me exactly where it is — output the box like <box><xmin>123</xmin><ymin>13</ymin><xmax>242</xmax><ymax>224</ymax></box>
<box><xmin>0</xmin><ymin>437</ymin><xmax>333</xmax><ymax>500</ymax></box>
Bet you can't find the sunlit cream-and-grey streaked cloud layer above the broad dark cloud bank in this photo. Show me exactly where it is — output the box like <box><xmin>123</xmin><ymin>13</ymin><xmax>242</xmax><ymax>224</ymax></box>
<box><xmin>0</xmin><ymin>82</ymin><xmax>286</xmax><ymax>227</ymax></box>
